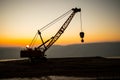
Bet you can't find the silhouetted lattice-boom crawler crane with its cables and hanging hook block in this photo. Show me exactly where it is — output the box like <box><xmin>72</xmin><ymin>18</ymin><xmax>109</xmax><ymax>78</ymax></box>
<box><xmin>20</xmin><ymin>8</ymin><xmax>84</xmax><ymax>62</ymax></box>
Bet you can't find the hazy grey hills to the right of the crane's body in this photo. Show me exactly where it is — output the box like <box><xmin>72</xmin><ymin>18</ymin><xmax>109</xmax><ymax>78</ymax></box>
<box><xmin>46</xmin><ymin>42</ymin><xmax>120</xmax><ymax>57</ymax></box>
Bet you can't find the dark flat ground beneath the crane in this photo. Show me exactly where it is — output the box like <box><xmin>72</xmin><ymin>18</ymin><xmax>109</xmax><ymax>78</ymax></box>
<box><xmin>0</xmin><ymin>57</ymin><xmax>120</xmax><ymax>78</ymax></box>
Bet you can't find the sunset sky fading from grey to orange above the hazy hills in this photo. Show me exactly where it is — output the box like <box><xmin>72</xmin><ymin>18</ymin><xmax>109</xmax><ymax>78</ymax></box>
<box><xmin>0</xmin><ymin>0</ymin><xmax>120</xmax><ymax>46</ymax></box>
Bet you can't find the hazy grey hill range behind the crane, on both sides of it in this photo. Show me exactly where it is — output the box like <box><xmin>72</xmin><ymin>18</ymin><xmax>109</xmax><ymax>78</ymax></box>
<box><xmin>0</xmin><ymin>42</ymin><xmax>120</xmax><ymax>59</ymax></box>
